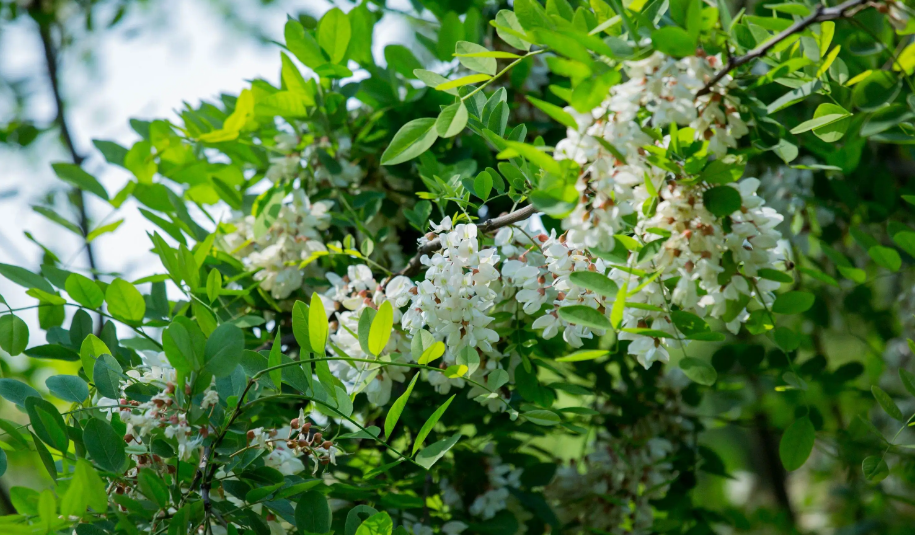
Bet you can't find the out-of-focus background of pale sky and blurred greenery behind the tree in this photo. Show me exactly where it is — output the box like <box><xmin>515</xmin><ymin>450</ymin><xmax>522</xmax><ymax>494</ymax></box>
<box><xmin>0</xmin><ymin>0</ymin><xmax>915</xmax><ymax>534</ymax></box>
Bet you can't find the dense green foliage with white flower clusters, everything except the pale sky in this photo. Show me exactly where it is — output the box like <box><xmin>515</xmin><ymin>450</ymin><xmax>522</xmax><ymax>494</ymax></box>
<box><xmin>0</xmin><ymin>0</ymin><xmax>915</xmax><ymax>535</ymax></box>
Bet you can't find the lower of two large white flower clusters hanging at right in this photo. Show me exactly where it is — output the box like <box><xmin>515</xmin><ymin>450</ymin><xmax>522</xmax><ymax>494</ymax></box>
<box><xmin>624</xmin><ymin>178</ymin><xmax>782</xmax><ymax>367</ymax></box>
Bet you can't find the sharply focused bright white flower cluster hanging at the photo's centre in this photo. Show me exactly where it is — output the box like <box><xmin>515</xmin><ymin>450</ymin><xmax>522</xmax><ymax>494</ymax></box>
<box><xmin>401</xmin><ymin>217</ymin><xmax>500</xmax><ymax>358</ymax></box>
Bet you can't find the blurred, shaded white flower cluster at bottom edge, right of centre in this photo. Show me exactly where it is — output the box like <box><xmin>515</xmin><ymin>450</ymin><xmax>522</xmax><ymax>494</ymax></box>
<box><xmin>544</xmin><ymin>374</ymin><xmax>693</xmax><ymax>535</ymax></box>
